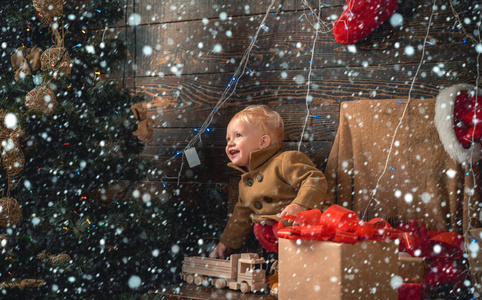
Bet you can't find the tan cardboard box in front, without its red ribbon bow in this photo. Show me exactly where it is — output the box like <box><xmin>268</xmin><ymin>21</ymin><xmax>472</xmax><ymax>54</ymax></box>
<box><xmin>278</xmin><ymin>238</ymin><xmax>400</xmax><ymax>300</ymax></box>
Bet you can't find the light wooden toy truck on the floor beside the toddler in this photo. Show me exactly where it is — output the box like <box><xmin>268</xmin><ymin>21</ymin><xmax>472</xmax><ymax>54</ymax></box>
<box><xmin>181</xmin><ymin>253</ymin><xmax>267</xmax><ymax>293</ymax></box>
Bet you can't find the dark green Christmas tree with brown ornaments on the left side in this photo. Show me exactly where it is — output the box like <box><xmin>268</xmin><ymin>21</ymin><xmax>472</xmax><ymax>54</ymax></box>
<box><xmin>0</xmin><ymin>0</ymin><xmax>200</xmax><ymax>299</ymax></box>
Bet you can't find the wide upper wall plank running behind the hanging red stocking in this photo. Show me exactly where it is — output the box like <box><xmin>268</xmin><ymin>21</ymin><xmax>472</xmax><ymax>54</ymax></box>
<box><xmin>131</xmin><ymin>1</ymin><xmax>475</xmax><ymax>76</ymax></box>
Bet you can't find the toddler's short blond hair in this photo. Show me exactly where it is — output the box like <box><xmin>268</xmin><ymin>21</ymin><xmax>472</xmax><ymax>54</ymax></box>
<box><xmin>231</xmin><ymin>105</ymin><xmax>284</xmax><ymax>146</ymax></box>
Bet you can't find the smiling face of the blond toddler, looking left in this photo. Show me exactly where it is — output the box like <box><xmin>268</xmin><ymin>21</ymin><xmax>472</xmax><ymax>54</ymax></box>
<box><xmin>226</xmin><ymin>118</ymin><xmax>270</xmax><ymax>169</ymax></box>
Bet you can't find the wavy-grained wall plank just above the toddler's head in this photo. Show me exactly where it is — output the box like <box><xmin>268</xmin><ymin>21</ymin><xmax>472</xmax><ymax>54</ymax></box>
<box><xmin>129</xmin><ymin>61</ymin><xmax>476</xmax><ymax>134</ymax></box>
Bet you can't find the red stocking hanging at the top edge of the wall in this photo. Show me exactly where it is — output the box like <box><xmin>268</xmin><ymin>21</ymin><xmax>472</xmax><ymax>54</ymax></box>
<box><xmin>333</xmin><ymin>0</ymin><xmax>398</xmax><ymax>45</ymax></box>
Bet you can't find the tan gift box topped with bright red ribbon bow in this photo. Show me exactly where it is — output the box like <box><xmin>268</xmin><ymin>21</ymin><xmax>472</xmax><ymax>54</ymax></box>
<box><xmin>278</xmin><ymin>205</ymin><xmax>402</xmax><ymax>300</ymax></box>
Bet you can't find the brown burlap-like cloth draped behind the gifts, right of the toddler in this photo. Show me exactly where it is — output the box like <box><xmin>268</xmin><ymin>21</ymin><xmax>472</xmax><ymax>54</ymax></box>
<box><xmin>325</xmin><ymin>99</ymin><xmax>480</xmax><ymax>233</ymax></box>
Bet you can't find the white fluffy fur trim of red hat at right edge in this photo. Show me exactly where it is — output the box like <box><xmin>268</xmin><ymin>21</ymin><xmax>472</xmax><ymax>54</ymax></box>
<box><xmin>434</xmin><ymin>83</ymin><xmax>482</xmax><ymax>163</ymax></box>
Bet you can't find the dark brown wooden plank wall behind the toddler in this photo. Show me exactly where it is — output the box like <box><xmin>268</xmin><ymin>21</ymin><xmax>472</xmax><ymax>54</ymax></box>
<box><xmin>106</xmin><ymin>0</ymin><xmax>480</xmax><ymax>244</ymax></box>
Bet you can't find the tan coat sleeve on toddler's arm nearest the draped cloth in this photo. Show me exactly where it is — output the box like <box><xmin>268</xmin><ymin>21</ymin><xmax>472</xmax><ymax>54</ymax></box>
<box><xmin>281</xmin><ymin>151</ymin><xmax>331</xmax><ymax>210</ymax></box>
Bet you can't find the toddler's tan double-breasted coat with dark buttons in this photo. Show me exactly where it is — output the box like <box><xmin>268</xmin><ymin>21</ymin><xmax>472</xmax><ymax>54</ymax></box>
<box><xmin>220</xmin><ymin>146</ymin><xmax>329</xmax><ymax>249</ymax></box>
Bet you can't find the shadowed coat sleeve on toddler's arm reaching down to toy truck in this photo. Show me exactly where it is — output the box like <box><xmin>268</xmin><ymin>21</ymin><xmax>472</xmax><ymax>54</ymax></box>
<box><xmin>220</xmin><ymin>199</ymin><xmax>253</xmax><ymax>249</ymax></box>
